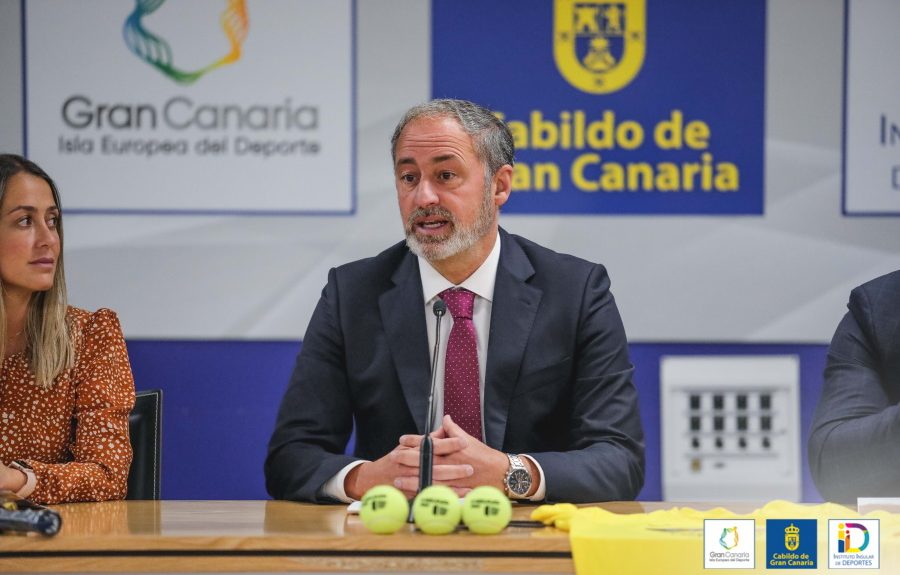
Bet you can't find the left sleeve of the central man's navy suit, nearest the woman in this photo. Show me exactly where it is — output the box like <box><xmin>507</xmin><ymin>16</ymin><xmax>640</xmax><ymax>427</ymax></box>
<box><xmin>265</xmin><ymin>270</ymin><xmax>354</xmax><ymax>503</ymax></box>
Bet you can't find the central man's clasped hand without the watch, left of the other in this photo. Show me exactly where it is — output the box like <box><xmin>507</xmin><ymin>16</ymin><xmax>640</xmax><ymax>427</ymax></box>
<box><xmin>344</xmin><ymin>430</ymin><xmax>474</xmax><ymax>500</ymax></box>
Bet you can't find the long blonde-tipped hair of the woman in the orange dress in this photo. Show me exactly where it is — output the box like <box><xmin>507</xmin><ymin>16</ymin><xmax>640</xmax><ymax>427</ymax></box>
<box><xmin>0</xmin><ymin>154</ymin><xmax>75</xmax><ymax>389</ymax></box>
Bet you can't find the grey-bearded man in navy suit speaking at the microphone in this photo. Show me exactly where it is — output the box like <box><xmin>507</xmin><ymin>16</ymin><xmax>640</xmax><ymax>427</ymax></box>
<box><xmin>265</xmin><ymin>100</ymin><xmax>644</xmax><ymax>502</ymax></box>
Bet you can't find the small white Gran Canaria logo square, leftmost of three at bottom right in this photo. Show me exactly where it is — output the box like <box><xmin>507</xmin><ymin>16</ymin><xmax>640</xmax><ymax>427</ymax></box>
<box><xmin>703</xmin><ymin>519</ymin><xmax>756</xmax><ymax>569</ymax></box>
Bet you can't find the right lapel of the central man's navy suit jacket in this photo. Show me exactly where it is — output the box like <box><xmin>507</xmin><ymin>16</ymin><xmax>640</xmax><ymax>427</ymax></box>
<box><xmin>484</xmin><ymin>229</ymin><xmax>542</xmax><ymax>449</ymax></box>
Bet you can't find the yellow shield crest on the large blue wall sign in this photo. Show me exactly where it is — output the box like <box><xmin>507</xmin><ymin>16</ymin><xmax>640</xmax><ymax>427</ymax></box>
<box><xmin>553</xmin><ymin>0</ymin><xmax>646</xmax><ymax>94</ymax></box>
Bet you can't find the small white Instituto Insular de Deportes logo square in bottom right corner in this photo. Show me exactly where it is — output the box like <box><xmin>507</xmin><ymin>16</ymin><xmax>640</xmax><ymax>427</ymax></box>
<box><xmin>828</xmin><ymin>519</ymin><xmax>881</xmax><ymax>569</ymax></box>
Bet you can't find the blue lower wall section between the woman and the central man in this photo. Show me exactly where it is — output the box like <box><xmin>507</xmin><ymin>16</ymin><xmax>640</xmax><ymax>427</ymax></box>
<box><xmin>128</xmin><ymin>340</ymin><xmax>300</xmax><ymax>499</ymax></box>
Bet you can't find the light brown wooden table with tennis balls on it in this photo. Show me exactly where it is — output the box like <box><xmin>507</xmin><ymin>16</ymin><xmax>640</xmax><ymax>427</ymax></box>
<box><xmin>0</xmin><ymin>501</ymin><xmax>646</xmax><ymax>573</ymax></box>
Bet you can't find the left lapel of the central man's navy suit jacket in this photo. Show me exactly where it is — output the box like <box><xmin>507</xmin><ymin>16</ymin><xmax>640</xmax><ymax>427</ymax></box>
<box><xmin>378</xmin><ymin>253</ymin><xmax>431</xmax><ymax>433</ymax></box>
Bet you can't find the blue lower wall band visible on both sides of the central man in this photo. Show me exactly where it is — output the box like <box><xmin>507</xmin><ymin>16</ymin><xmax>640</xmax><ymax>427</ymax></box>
<box><xmin>128</xmin><ymin>340</ymin><xmax>827</xmax><ymax>501</ymax></box>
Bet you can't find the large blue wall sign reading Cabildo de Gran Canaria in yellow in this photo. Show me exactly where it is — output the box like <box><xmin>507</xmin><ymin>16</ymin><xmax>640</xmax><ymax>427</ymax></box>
<box><xmin>432</xmin><ymin>0</ymin><xmax>766</xmax><ymax>214</ymax></box>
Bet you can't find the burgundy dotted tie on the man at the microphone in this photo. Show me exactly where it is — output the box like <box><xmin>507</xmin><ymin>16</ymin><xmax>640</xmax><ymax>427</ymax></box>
<box><xmin>440</xmin><ymin>289</ymin><xmax>481</xmax><ymax>441</ymax></box>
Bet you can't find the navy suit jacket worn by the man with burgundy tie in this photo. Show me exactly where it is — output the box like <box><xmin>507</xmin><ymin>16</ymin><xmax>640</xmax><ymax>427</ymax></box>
<box><xmin>265</xmin><ymin>230</ymin><xmax>644</xmax><ymax>502</ymax></box>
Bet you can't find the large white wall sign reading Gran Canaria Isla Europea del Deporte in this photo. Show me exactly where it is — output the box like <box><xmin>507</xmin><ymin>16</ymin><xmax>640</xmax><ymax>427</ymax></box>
<box><xmin>24</xmin><ymin>0</ymin><xmax>355</xmax><ymax>214</ymax></box>
